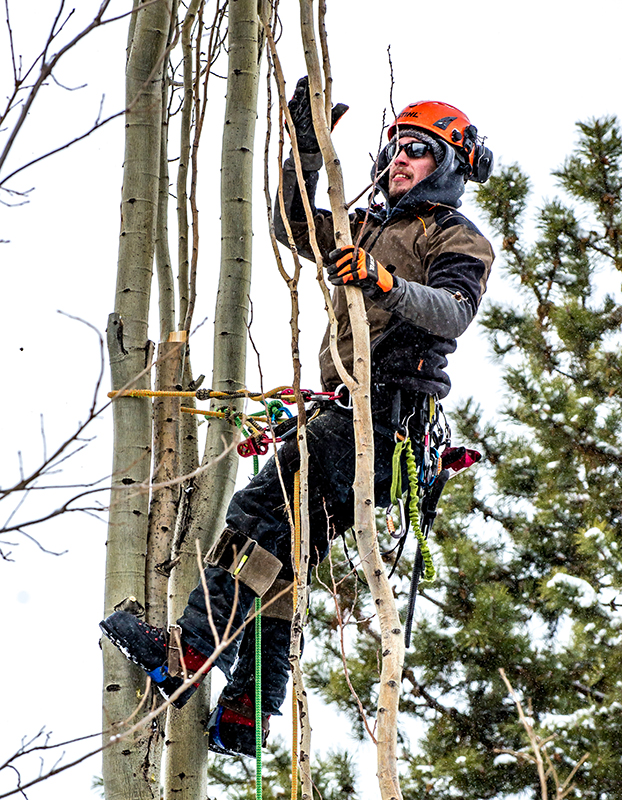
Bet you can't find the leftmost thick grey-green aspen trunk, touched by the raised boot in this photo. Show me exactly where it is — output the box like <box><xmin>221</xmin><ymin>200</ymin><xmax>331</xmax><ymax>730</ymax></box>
<box><xmin>103</xmin><ymin>0</ymin><xmax>171</xmax><ymax>800</ymax></box>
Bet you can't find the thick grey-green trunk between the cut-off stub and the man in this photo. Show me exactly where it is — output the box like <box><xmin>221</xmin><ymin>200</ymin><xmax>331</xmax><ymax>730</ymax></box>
<box><xmin>163</xmin><ymin>0</ymin><xmax>258</xmax><ymax>800</ymax></box>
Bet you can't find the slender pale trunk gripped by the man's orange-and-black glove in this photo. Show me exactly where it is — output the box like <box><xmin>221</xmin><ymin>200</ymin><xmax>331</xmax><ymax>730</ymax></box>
<box><xmin>300</xmin><ymin>0</ymin><xmax>404</xmax><ymax>800</ymax></box>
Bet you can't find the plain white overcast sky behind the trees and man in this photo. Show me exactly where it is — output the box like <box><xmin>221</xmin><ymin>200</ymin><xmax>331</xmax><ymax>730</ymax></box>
<box><xmin>0</xmin><ymin>0</ymin><xmax>622</xmax><ymax>800</ymax></box>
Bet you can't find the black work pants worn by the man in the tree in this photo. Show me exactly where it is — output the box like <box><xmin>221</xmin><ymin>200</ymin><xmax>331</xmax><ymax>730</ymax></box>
<box><xmin>179</xmin><ymin>406</ymin><xmax>416</xmax><ymax>714</ymax></box>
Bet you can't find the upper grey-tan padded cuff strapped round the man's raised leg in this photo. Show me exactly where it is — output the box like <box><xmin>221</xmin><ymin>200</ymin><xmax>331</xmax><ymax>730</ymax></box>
<box><xmin>205</xmin><ymin>528</ymin><xmax>283</xmax><ymax>597</ymax></box>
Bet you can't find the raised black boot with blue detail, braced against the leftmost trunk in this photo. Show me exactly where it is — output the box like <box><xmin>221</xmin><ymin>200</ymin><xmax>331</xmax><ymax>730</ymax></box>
<box><xmin>99</xmin><ymin>611</ymin><xmax>209</xmax><ymax>708</ymax></box>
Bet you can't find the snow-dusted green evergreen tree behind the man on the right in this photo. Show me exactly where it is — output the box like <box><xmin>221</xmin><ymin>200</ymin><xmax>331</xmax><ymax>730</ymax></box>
<box><xmin>296</xmin><ymin>118</ymin><xmax>622</xmax><ymax>800</ymax></box>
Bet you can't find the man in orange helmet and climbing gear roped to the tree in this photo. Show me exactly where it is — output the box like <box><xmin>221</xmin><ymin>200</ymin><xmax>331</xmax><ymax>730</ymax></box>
<box><xmin>101</xmin><ymin>78</ymin><xmax>494</xmax><ymax>755</ymax></box>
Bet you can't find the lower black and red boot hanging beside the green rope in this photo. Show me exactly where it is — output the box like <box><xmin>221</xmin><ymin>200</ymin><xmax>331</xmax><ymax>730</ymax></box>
<box><xmin>207</xmin><ymin>694</ymin><xmax>270</xmax><ymax>758</ymax></box>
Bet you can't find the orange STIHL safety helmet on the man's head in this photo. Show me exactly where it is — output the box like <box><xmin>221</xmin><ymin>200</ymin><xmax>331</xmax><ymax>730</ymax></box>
<box><xmin>388</xmin><ymin>100</ymin><xmax>493</xmax><ymax>183</ymax></box>
